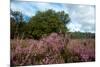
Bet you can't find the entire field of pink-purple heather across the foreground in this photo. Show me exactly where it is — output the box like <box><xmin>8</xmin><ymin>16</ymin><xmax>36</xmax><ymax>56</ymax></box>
<box><xmin>11</xmin><ymin>33</ymin><xmax>95</xmax><ymax>66</ymax></box>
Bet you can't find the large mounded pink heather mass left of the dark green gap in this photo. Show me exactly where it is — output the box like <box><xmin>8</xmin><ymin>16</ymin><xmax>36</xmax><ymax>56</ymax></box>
<box><xmin>11</xmin><ymin>33</ymin><xmax>67</xmax><ymax>65</ymax></box>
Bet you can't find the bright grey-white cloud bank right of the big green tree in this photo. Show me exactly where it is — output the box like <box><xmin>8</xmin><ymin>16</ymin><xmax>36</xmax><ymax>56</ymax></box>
<box><xmin>66</xmin><ymin>5</ymin><xmax>95</xmax><ymax>32</ymax></box>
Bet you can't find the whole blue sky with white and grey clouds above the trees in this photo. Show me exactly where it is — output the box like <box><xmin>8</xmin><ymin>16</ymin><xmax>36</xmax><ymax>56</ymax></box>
<box><xmin>11</xmin><ymin>1</ymin><xmax>96</xmax><ymax>33</ymax></box>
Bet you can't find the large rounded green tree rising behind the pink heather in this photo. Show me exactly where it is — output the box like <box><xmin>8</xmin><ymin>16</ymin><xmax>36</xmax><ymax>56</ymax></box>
<box><xmin>28</xmin><ymin>9</ymin><xmax>70</xmax><ymax>39</ymax></box>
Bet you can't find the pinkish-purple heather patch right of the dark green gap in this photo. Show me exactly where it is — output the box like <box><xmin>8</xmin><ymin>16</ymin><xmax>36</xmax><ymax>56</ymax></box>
<box><xmin>68</xmin><ymin>39</ymin><xmax>95</xmax><ymax>61</ymax></box>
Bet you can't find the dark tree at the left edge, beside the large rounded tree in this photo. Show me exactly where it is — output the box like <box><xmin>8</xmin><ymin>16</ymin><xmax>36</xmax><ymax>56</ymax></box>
<box><xmin>10</xmin><ymin>10</ymin><xmax>26</xmax><ymax>38</ymax></box>
